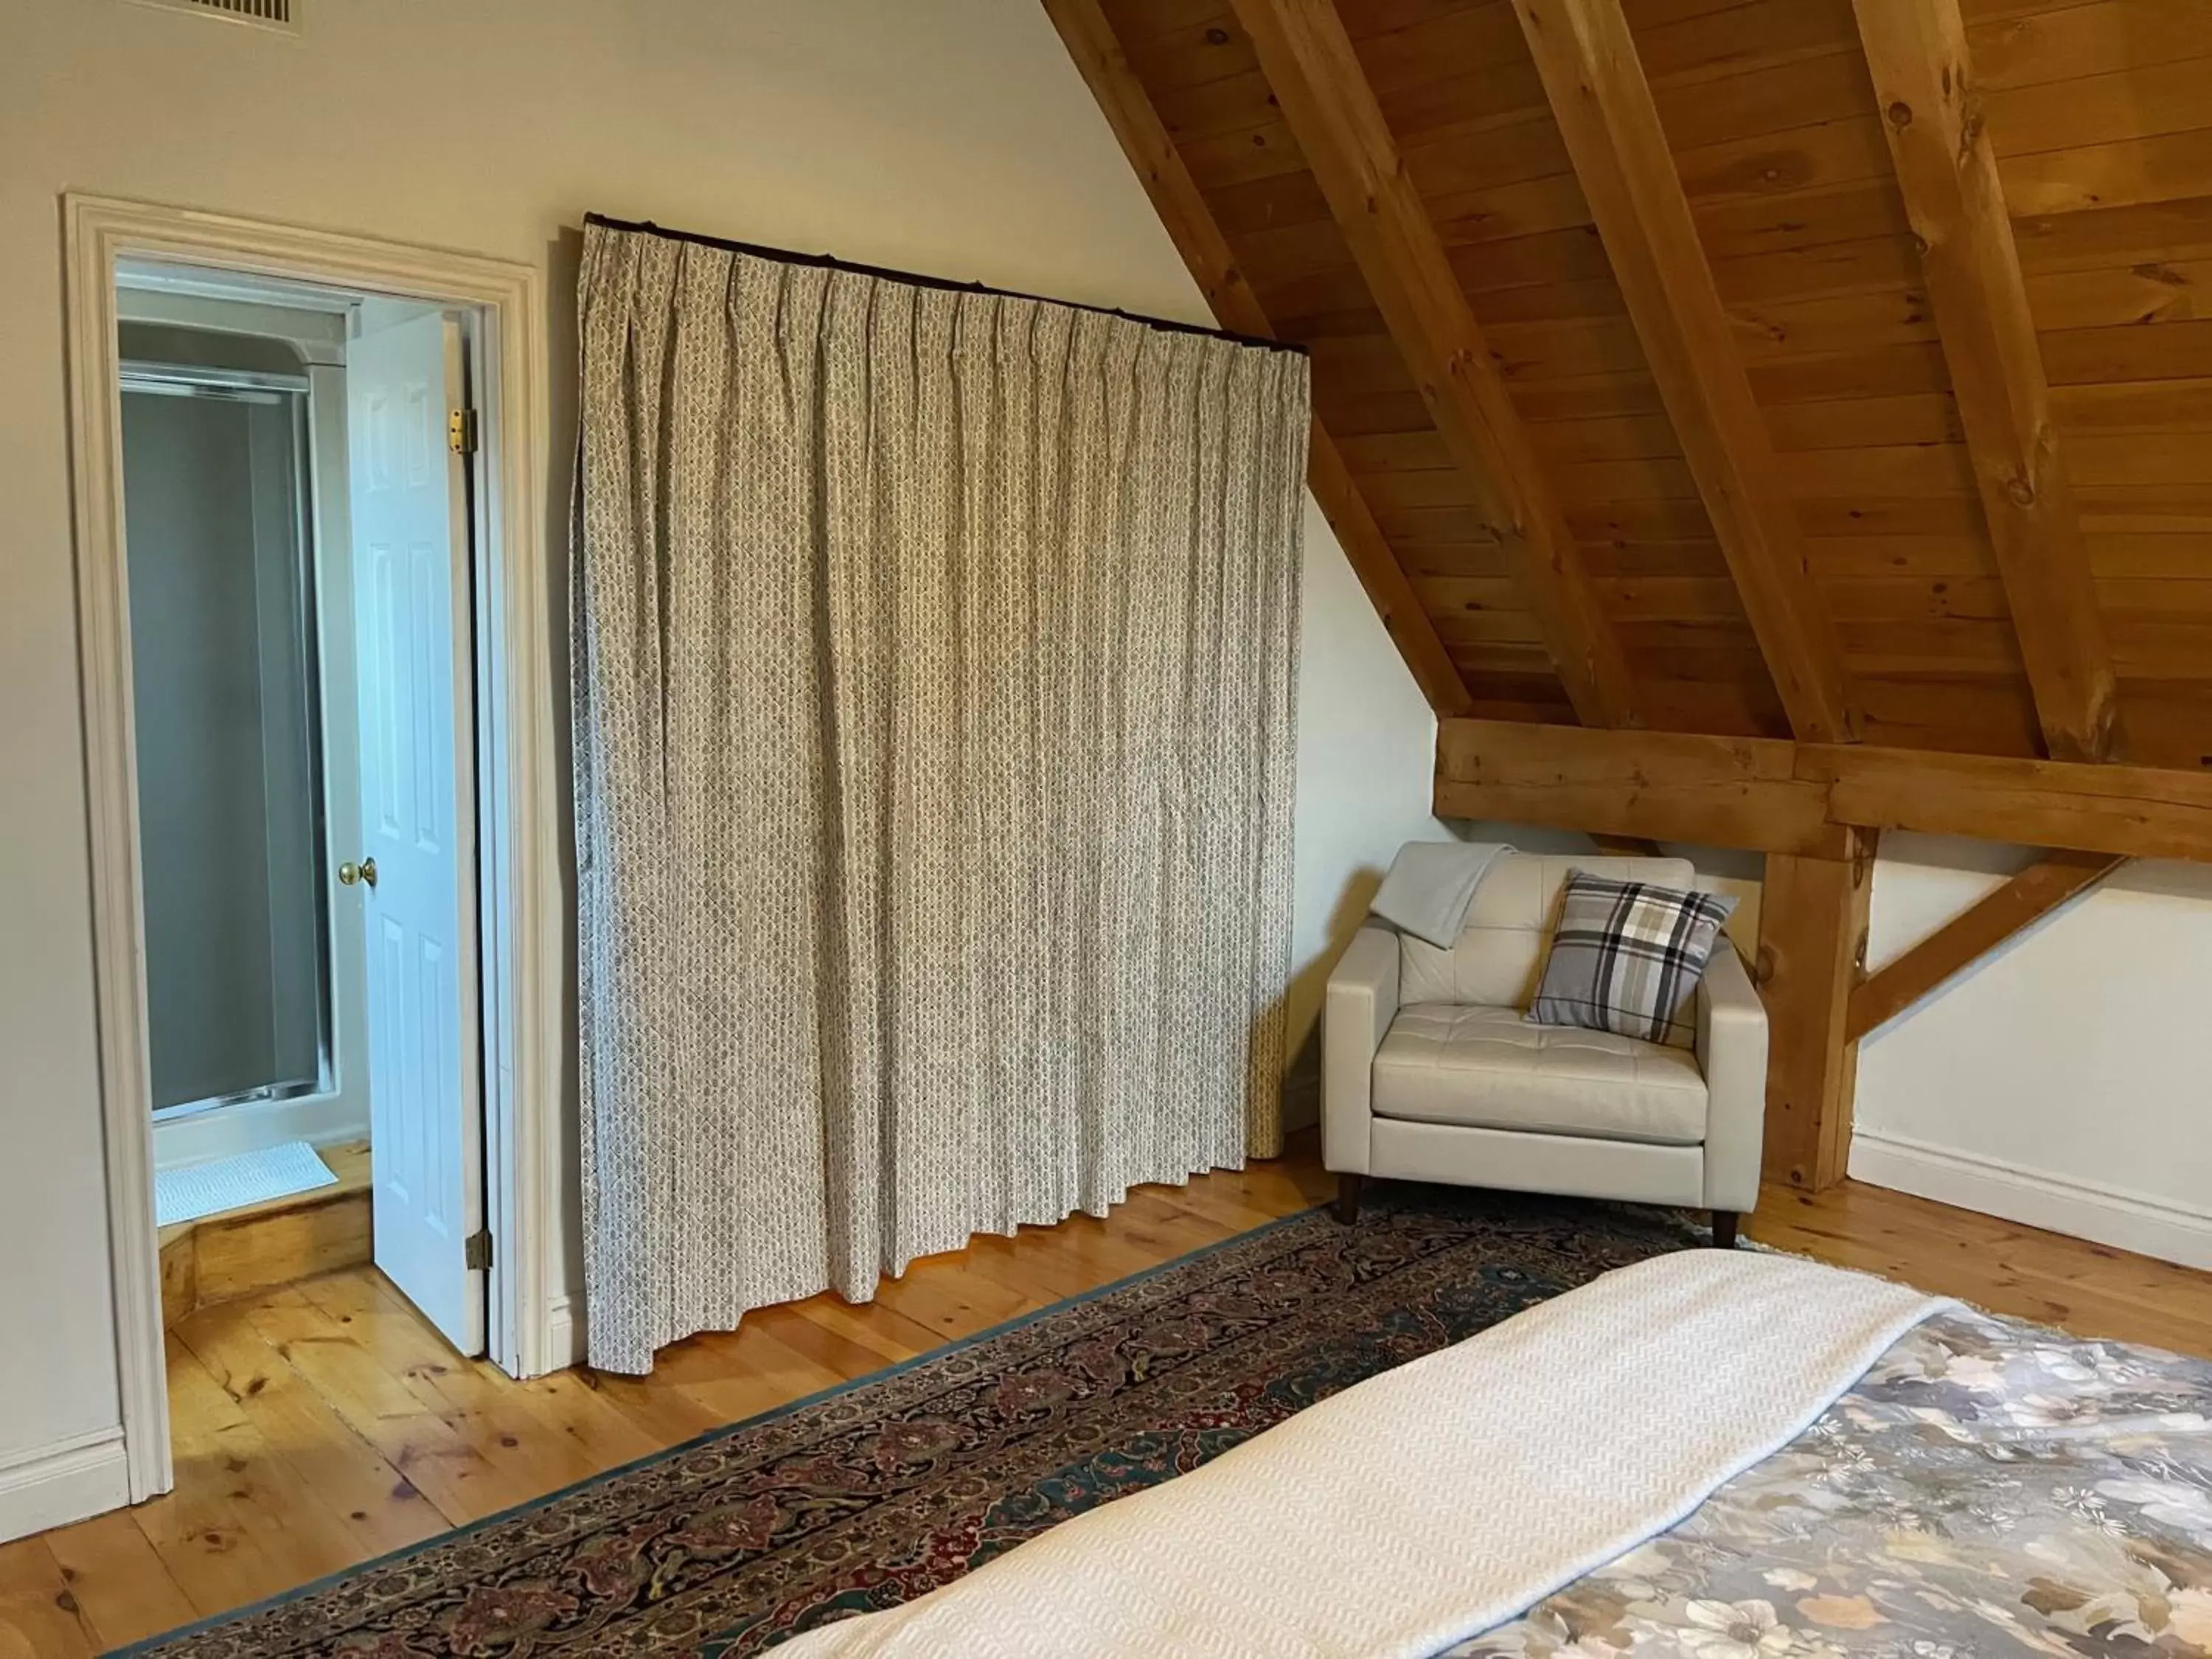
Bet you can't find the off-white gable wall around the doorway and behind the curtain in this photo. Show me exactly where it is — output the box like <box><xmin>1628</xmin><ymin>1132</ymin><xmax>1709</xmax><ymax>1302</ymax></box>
<box><xmin>0</xmin><ymin>0</ymin><xmax>1429</xmax><ymax>1535</ymax></box>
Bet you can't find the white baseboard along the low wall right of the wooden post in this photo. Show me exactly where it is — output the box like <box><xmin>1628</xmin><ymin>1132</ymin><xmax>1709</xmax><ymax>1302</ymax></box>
<box><xmin>1851</xmin><ymin>1128</ymin><xmax>2212</xmax><ymax>1267</ymax></box>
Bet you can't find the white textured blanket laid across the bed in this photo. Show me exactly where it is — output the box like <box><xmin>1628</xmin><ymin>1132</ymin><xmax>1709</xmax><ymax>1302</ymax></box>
<box><xmin>779</xmin><ymin>1250</ymin><xmax>1947</xmax><ymax>1659</ymax></box>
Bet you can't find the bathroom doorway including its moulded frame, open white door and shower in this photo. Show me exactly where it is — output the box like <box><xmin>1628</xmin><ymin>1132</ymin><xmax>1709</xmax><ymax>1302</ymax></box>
<box><xmin>64</xmin><ymin>195</ymin><xmax>562</xmax><ymax>1502</ymax></box>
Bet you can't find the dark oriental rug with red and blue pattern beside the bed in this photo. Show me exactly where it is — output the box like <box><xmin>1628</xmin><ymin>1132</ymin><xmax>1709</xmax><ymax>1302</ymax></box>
<box><xmin>128</xmin><ymin>1188</ymin><xmax>1701</xmax><ymax>1659</ymax></box>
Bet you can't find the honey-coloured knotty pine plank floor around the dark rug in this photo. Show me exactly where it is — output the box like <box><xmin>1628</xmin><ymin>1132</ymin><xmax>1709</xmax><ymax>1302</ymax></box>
<box><xmin>0</xmin><ymin>1135</ymin><xmax>2212</xmax><ymax>1659</ymax></box>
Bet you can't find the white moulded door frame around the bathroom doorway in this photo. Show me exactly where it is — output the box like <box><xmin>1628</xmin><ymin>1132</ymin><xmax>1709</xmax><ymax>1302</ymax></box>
<box><xmin>62</xmin><ymin>195</ymin><xmax>571</xmax><ymax>1502</ymax></box>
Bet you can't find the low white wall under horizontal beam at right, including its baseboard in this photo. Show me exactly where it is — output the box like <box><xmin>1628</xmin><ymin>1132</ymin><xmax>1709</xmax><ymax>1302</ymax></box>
<box><xmin>1851</xmin><ymin>834</ymin><xmax>2212</xmax><ymax>1267</ymax></box>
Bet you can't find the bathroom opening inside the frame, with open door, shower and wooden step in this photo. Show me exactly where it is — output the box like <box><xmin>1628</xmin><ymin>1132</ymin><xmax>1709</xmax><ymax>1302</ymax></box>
<box><xmin>115</xmin><ymin>261</ymin><xmax>489</xmax><ymax>1356</ymax></box>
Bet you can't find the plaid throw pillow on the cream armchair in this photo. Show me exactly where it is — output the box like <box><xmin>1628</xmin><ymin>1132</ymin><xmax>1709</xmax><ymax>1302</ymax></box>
<box><xmin>1528</xmin><ymin>869</ymin><xmax>1736</xmax><ymax>1048</ymax></box>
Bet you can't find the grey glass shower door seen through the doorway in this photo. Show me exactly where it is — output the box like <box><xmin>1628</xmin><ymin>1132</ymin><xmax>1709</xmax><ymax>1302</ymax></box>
<box><xmin>122</xmin><ymin>365</ymin><xmax>332</xmax><ymax>1115</ymax></box>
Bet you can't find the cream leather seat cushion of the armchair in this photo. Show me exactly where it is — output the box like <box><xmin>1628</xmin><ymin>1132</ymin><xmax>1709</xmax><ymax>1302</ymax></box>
<box><xmin>1363</xmin><ymin>1002</ymin><xmax>1705</xmax><ymax>1168</ymax></box>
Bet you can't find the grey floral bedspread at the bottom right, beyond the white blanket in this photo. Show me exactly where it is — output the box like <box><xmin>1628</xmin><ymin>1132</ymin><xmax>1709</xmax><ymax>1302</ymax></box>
<box><xmin>1451</xmin><ymin>1310</ymin><xmax>2212</xmax><ymax>1659</ymax></box>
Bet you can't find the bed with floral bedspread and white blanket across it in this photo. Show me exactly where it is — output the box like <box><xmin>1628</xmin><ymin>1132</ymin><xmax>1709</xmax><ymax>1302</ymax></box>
<box><xmin>783</xmin><ymin>1250</ymin><xmax>2212</xmax><ymax>1659</ymax></box>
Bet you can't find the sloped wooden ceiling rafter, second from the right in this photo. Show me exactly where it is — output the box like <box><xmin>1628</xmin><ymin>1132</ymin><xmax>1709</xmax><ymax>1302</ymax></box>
<box><xmin>1513</xmin><ymin>0</ymin><xmax>1858</xmax><ymax>743</ymax></box>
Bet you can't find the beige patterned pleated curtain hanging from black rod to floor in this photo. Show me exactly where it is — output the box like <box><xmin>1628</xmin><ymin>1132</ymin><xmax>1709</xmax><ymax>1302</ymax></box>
<box><xmin>575</xmin><ymin>223</ymin><xmax>1307</xmax><ymax>1371</ymax></box>
